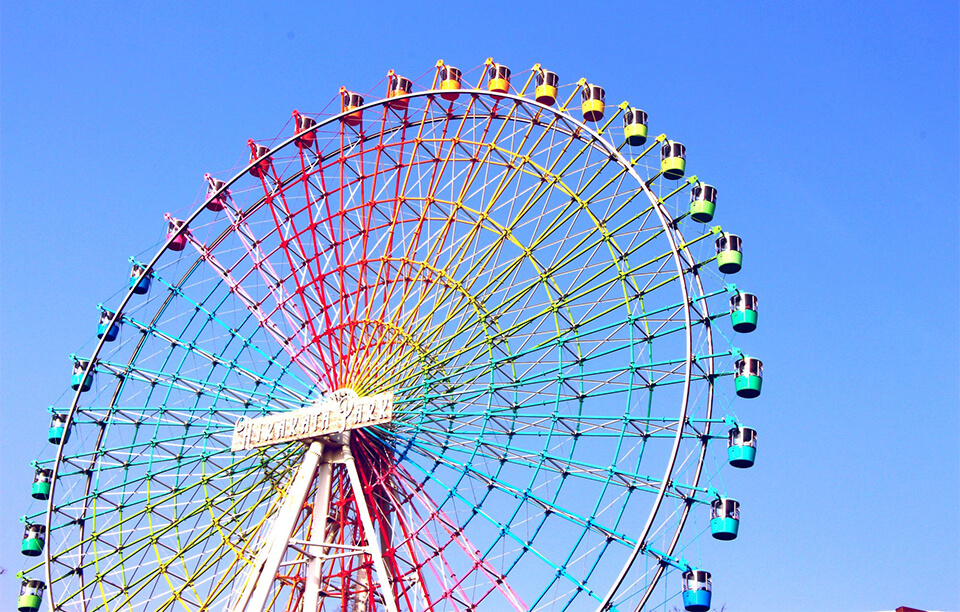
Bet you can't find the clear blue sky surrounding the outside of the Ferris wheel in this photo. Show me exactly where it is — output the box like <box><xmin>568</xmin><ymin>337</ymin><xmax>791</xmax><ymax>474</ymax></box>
<box><xmin>0</xmin><ymin>1</ymin><xmax>960</xmax><ymax>612</ymax></box>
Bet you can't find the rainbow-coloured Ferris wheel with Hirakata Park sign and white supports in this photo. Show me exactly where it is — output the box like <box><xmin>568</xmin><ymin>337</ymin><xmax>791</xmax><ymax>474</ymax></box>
<box><xmin>18</xmin><ymin>60</ymin><xmax>762</xmax><ymax>612</ymax></box>
